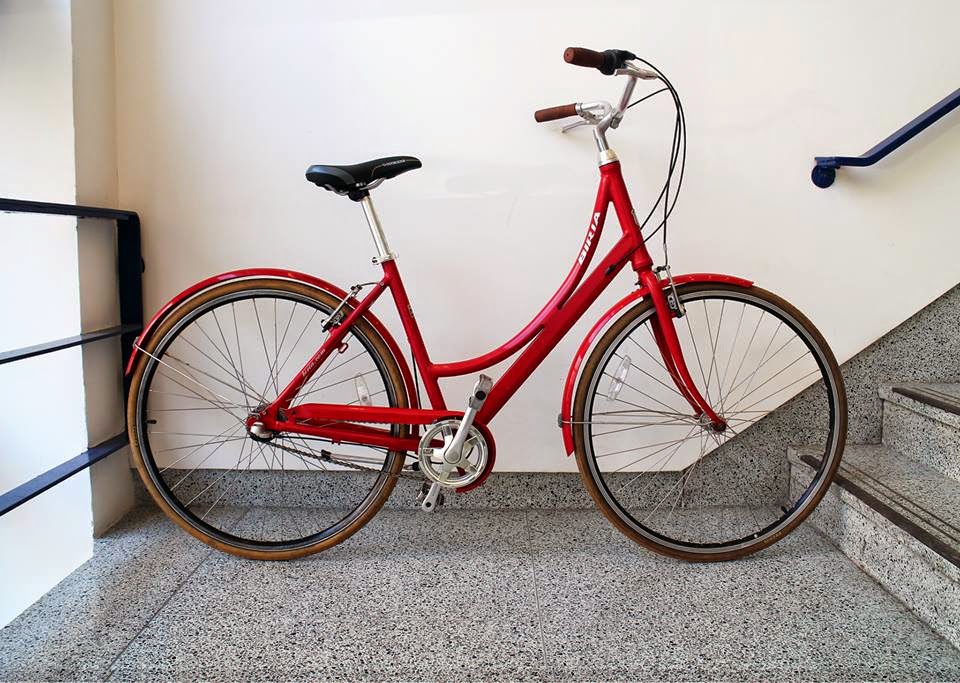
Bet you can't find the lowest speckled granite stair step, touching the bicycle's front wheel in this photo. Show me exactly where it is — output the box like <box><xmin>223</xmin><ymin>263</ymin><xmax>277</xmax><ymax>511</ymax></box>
<box><xmin>789</xmin><ymin>445</ymin><xmax>960</xmax><ymax>647</ymax></box>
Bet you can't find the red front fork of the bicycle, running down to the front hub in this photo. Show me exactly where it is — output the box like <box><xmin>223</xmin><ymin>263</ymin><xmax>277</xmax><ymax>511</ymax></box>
<box><xmin>640</xmin><ymin>269</ymin><xmax>727</xmax><ymax>432</ymax></box>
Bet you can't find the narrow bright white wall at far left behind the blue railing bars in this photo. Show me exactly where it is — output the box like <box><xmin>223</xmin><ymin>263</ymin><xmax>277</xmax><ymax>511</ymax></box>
<box><xmin>0</xmin><ymin>0</ymin><xmax>93</xmax><ymax>625</ymax></box>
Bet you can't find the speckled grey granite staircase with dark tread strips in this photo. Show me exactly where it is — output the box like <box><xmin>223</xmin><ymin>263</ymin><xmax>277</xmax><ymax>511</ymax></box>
<box><xmin>789</xmin><ymin>383</ymin><xmax>960</xmax><ymax>648</ymax></box>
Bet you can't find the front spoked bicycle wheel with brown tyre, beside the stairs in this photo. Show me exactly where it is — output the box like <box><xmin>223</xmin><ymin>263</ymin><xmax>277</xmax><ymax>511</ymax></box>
<box><xmin>573</xmin><ymin>283</ymin><xmax>847</xmax><ymax>561</ymax></box>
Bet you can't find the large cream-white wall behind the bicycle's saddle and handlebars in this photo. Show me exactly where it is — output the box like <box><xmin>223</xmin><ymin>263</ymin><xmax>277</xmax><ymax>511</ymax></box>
<box><xmin>115</xmin><ymin>0</ymin><xmax>960</xmax><ymax>470</ymax></box>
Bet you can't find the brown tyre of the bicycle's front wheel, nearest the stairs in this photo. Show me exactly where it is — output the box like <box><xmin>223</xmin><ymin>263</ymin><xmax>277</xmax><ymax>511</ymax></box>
<box><xmin>573</xmin><ymin>283</ymin><xmax>847</xmax><ymax>562</ymax></box>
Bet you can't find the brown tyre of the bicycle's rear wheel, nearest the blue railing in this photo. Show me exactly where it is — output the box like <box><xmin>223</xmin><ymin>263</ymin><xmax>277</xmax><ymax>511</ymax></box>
<box><xmin>127</xmin><ymin>279</ymin><xmax>409</xmax><ymax>560</ymax></box>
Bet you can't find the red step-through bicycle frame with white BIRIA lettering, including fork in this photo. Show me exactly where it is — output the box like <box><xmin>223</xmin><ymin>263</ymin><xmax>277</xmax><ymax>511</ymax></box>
<box><xmin>251</xmin><ymin>161</ymin><xmax>725</xmax><ymax>451</ymax></box>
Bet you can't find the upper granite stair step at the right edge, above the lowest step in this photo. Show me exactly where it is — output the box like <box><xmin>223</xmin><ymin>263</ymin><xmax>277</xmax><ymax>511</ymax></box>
<box><xmin>880</xmin><ymin>383</ymin><xmax>960</xmax><ymax>481</ymax></box>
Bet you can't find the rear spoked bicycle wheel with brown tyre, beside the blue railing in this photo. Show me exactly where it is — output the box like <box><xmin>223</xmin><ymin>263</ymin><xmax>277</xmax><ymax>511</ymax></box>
<box><xmin>127</xmin><ymin>279</ymin><xmax>407</xmax><ymax>559</ymax></box>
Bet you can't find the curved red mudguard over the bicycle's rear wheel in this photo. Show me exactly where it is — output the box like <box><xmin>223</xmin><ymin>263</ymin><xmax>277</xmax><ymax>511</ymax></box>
<box><xmin>126</xmin><ymin>268</ymin><xmax>420</xmax><ymax>408</ymax></box>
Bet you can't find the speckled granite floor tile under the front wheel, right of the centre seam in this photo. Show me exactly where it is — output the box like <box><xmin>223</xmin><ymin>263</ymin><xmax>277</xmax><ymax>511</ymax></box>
<box><xmin>532</xmin><ymin>515</ymin><xmax>960</xmax><ymax>680</ymax></box>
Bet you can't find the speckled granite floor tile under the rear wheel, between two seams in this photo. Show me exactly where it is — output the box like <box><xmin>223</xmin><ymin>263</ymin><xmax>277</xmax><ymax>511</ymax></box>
<box><xmin>106</xmin><ymin>511</ymin><xmax>543</xmax><ymax>680</ymax></box>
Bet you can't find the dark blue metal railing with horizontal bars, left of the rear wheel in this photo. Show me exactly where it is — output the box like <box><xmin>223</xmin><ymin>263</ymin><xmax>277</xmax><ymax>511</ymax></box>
<box><xmin>0</xmin><ymin>198</ymin><xmax>143</xmax><ymax>515</ymax></box>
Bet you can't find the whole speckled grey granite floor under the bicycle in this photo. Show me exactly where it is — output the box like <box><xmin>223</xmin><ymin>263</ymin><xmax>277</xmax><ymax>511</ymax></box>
<box><xmin>0</xmin><ymin>509</ymin><xmax>960</xmax><ymax>680</ymax></box>
